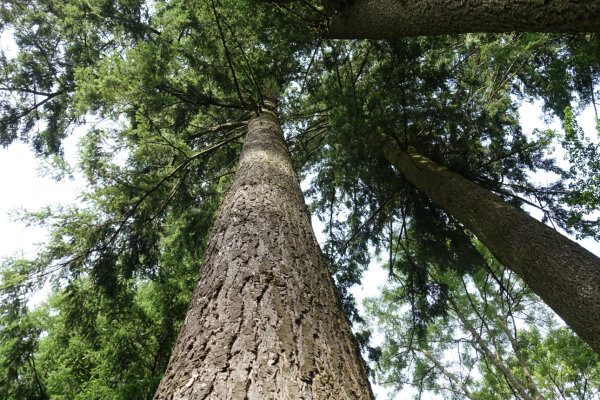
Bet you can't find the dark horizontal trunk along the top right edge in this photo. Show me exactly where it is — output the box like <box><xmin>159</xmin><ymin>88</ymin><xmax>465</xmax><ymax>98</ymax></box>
<box><xmin>326</xmin><ymin>0</ymin><xmax>600</xmax><ymax>39</ymax></box>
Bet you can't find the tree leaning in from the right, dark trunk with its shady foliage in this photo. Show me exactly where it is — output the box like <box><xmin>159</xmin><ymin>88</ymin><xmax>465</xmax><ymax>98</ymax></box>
<box><xmin>298</xmin><ymin>35</ymin><xmax>600</xmax><ymax>348</ymax></box>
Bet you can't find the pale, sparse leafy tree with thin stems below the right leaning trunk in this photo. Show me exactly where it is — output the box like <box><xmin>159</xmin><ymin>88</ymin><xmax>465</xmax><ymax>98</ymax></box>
<box><xmin>368</xmin><ymin>236</ymin><xmax>600</xmax><ymax>399</ymax></box>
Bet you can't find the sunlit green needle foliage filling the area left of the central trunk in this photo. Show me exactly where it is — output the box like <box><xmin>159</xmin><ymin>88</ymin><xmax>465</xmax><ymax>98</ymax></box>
<box><xmin>0</xmin><ymin>1</ymin><xmax>316</xmax><ymax>399</ymax></box>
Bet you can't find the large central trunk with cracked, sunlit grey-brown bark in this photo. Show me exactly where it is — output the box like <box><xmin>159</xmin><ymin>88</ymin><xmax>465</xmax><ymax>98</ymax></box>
<box><xmin>155</xmin><ymin>104</ymin><xmax>373</xmax><ymax>400</ymax></box>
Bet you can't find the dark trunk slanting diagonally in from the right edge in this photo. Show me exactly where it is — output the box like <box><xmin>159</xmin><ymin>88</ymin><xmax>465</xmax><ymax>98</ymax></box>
<box><xmin>370</xmin><ymin>135</ymin><xmax>600</xmax><ymax>353</ymax></box>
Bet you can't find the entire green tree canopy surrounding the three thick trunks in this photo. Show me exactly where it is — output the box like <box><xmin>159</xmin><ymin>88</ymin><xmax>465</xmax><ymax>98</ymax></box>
<box><xmin>0</xmin><ymin>0</ymin><xmax>600</xmax><ymax>399</ymax></box>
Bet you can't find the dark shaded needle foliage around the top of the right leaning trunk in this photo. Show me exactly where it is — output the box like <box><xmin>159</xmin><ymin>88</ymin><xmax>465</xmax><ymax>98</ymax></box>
<box><xmin>302</xmin><ymin>35</ymin><xmax>557</xmax><ymax>323</ymax></box>
